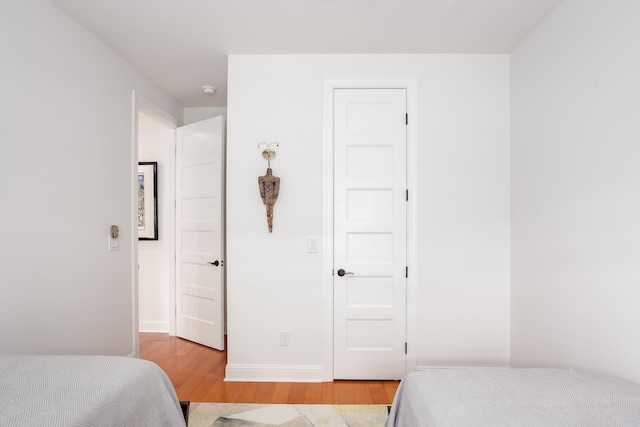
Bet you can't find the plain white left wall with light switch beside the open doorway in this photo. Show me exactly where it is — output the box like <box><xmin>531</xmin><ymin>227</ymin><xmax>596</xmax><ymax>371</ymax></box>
<box><xmin>0</xmin><ymin>0</ymin><xmax>182</xmax><ymax>355</ymax></box>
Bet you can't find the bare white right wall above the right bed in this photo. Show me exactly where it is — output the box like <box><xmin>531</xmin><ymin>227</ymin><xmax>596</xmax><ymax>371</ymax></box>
<box><xmin>511</xmin><ymin>0</ymin><xmax>640</xmax><ymax>381</ymax></box>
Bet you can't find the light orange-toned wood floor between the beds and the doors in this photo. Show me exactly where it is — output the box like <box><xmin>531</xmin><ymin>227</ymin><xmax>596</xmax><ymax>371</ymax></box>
<box><xmin>140</xmin><ymin>332</ymin><xmax>399</xmax><ymax>404</ymax></box>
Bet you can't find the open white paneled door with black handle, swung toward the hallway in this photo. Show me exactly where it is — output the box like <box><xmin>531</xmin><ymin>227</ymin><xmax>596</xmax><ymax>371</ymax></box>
<box><xmin>176</xmin><ymin>116</ymin><xmax>224</xmax><ymax>350</ymax></box>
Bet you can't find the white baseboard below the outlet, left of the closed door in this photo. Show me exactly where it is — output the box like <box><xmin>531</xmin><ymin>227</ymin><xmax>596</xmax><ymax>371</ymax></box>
<box><xmin>224</xmin><ymin>365</ymin><xmax>324</xmax><ymax>383</ymax></box>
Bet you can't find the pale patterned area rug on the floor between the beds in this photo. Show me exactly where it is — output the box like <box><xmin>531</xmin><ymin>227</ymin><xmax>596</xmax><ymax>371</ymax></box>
<box><xmin>189</xmin><ymin>402</ymin><xmax>388</xmax><ymax>427</ymax></box>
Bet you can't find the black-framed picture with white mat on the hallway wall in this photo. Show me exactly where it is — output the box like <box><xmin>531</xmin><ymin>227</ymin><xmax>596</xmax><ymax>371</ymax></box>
<box><xmin>138</xmin><ymin>162</ymin><xmax>158</xmax><ymax>240</ymax></box>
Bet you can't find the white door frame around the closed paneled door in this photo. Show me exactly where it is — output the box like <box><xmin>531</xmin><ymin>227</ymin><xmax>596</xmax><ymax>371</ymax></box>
<box><xmin>322</xmin><ymin>80</ymin><xmax>419</xmax><ymax>381</ymax></box>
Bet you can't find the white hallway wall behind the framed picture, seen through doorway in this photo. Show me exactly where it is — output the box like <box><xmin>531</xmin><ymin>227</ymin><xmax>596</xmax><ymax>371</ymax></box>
<box><xmin>138</xmin><ymin>113</ymin><xmax>176</xmax><ymax>332</ymax></box>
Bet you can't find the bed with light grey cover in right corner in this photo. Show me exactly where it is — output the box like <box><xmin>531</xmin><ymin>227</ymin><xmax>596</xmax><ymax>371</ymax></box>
<box><xmin>387</xmin><ymin>368</ymin><xmax>640</xmax><ymax>427</ymax></box>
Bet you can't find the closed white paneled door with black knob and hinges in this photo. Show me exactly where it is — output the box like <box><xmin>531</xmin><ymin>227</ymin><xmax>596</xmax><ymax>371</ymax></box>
<box><xmin>333</xmin><ymin>89</ymin><xmax>407</xmax><ymax>380</ymax></box>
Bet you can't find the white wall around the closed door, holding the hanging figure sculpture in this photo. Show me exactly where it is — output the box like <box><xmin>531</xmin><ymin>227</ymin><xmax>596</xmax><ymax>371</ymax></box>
<box><xmin>226</xmin><ymin>55</ymin><xmax>510</xmax><ymax>379</ymax></box>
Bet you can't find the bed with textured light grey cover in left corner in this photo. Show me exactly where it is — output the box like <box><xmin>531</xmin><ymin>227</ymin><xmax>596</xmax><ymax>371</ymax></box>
<box><xmin>0</xmin><ymin>355</ymin><xmax>185</xmax><ymax>427</ymax></box>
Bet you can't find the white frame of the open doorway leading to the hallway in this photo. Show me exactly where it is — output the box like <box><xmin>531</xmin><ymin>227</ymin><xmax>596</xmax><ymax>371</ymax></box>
<box><xmin>131</xmin><ymin>90</ymin><xmax>179</xmax><ymax>357</ymax></box>
